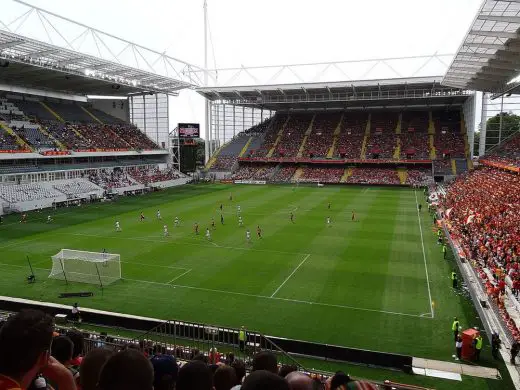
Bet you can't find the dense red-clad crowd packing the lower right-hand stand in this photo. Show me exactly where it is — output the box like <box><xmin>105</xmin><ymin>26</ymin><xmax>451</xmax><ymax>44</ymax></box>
<box><xmin>441</xmin><ymin>167</ymin><xmax>520</xmax><ymax>336</ymax></box>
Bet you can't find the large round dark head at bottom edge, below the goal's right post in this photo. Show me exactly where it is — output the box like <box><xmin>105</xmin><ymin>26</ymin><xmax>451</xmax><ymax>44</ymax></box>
<box><xmin>98</xmin><ymin>349</ymin><xmax>153</xmax><ymax>390</ymax></box>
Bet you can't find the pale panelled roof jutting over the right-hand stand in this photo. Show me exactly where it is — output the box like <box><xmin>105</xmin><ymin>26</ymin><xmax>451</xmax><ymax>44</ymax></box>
<box><xmin>442</xmin><ymin>0</ymin><xmax>520</xmax><ymax>93</ymax></box>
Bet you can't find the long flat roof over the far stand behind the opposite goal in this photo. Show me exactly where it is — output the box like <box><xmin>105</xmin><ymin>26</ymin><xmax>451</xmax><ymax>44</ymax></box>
<box><xmin>196</xmin><ymin>76</ymin><xmax>471</xmax><ymax>110</ymax></box>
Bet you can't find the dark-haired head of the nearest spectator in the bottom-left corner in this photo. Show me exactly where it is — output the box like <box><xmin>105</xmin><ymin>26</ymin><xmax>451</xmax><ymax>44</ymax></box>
<box><xmin>0</xmin><ymin>310</ymin><xmax>54</xmax><ymax>387</ymax></box>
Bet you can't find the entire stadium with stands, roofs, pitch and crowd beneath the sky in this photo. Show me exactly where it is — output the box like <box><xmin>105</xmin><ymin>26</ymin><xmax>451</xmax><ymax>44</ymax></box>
<box><xmin>0</xmin><ymin>0</ymin><xmax>520</xmax><ymax>390</ymax></box>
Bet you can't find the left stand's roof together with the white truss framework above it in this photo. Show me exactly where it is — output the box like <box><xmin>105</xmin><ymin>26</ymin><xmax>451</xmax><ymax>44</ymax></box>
<box><xmin>0</xmin><ymin>0</ymin><xmax>204</xmax><ymax>95</ymax></box>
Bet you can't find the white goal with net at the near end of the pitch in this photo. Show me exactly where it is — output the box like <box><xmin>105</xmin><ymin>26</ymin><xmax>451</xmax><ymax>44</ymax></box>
<box><xmin>49</xmin><ymin>249</ymin><xmax>121</xmax><ymax>286</ymax></box>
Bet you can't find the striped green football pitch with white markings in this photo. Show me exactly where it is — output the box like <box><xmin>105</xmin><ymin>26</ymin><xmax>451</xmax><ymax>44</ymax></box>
<box><xmin>0</xmin><ymin>184</ymin><xmax>475</xmax><ymax>360</ymax></box>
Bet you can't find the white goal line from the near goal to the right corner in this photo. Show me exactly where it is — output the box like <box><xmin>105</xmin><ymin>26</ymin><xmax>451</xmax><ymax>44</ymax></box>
<box><xmin>123</xmin><ymin>278</ymin><xmax>431</xmax><ymax>319</ymax></box>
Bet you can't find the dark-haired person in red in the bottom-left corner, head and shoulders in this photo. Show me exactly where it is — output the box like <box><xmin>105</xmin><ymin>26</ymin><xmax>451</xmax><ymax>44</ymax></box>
<box><xmin>0</xmin><ymin>310</ymin><xmax>76</xmax><ymax>390</ymax></box>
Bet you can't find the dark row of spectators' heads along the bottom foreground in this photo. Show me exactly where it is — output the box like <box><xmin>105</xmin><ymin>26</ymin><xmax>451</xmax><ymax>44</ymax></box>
<box><xmin>0</xmin><ymin>310</ymin><xmax>377</xmax><ymax>390</ymax></box>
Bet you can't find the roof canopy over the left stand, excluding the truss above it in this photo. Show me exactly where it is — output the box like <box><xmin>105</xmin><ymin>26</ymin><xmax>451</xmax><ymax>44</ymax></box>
<box><xmin>0</xmin><ymin>29</ymin><xmax>192</xmax><ymax>95</ymax></box>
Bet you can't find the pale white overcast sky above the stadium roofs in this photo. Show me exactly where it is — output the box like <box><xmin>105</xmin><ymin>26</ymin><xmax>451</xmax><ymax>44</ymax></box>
<box><xmin>0</xmin><ymin>0</ymin><xmax>482</xmax><ymax>136</ymax></box>
